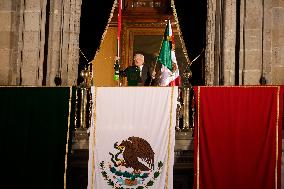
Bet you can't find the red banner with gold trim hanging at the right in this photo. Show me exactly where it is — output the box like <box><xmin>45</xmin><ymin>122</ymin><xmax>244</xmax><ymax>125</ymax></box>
<box><xmin>194</xmin><ymin>86</ymin><xmax>283</xmax><ymax>189</ymax></box>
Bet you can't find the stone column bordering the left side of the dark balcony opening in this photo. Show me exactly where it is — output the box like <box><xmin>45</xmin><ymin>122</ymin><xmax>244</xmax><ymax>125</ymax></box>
<box><xmin>46</xmin><ymin>0</ymin><xmax>82</xmax><ymax>86</ymax></box>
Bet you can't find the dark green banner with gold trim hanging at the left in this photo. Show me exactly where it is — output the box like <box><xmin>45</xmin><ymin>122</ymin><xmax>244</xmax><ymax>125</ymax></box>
<box><xmin>0</xmin><ymin>87</ymin><xmax>71</xmax><ymax>189</ymax></box>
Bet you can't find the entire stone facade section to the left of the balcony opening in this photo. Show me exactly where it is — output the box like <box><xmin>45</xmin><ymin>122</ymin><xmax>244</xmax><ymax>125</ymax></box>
<box><xmin>0</xmin><ymin>0</ymin><xmax>82</xmax><ymax>86</ymax></box>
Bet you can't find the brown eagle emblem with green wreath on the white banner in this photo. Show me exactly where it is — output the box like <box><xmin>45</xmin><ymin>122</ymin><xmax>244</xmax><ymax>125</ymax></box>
<box><xmin>100</xmin><ymin>136</ymin><xmax>163</xmax><ymax>189</ymax></box>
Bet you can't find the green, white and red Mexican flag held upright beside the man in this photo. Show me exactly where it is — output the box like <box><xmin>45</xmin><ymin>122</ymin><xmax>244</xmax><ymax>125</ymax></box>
<box><xmin>158</xmin><ymin>20</ymin><xmax>181</xmax><ymax>86</ymax></box>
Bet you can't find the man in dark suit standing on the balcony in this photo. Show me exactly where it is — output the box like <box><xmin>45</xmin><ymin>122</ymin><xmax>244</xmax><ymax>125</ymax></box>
<box><xmin>121</xmin><ymin>54</ymin><xmax>156</xmax><ymax>86</ymax></box>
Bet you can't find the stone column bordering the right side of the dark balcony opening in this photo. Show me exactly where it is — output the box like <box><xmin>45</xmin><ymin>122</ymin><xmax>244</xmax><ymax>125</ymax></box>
<box><xmin>205</xmin><ymin>0</ymin><xmax>236</xmax><ymax>85</ymax></box>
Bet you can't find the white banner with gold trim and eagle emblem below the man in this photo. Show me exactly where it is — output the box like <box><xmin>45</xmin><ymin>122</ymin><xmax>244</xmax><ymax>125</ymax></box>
<box><xmin>88</xmin><ymin>87</ymin><xmax>178</xmax><ymax>189</ymax></box>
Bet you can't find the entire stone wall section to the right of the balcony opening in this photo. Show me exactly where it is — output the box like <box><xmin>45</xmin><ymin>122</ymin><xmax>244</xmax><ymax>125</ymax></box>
<box><xmin>206</xmin><ymin>0</ymin><xmax>284</xmax><ymax>85</ymax></box>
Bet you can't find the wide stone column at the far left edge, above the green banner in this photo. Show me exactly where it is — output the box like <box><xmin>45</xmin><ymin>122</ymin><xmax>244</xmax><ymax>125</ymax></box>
<box><xmin>0</xmin><ymin>0</ymin><xmax>46</xmax><ymax>86</ymax></box>
